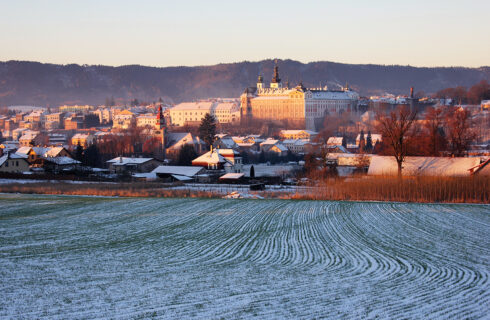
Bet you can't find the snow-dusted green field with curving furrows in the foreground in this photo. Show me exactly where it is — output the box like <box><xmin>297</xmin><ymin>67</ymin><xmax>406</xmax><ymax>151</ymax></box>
<box><xmin>0</xmin><ymin>194</ymin><xmax>490</xmax><ymax>319</ymax></box>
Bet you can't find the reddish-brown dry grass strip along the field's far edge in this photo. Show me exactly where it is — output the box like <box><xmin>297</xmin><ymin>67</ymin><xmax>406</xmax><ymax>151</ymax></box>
<box><xmin>0</xmin><ymin>177</ymin><xmax>490</xmax><ymax>203</ymax></box>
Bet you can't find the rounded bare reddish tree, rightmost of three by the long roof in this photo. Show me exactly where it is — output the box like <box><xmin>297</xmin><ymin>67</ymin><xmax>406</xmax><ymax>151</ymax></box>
<box><xmin>446</xmin><ymin>107</ymin><xmax>476</xmax><ymax>157</ymax></box>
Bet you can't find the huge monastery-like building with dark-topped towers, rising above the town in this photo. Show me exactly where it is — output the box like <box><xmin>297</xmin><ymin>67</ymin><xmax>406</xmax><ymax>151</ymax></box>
<box><xmin>240</xmin><ymin>64</ymin><xmax>359</xmax><ymax>130</ymax></box>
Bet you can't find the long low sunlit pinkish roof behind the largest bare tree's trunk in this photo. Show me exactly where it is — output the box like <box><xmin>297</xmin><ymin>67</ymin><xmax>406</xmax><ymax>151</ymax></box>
<box><xmin>368</xmin><ymin>156</ymin><xmax>480</xmax><ymax>177</ymax></box>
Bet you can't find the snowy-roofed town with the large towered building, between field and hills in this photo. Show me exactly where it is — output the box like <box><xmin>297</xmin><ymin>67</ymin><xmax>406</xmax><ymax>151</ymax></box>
<box><xmin>0</xmin><ymin>72</ymin><xmax>490</xmax><ymax>186</ymax></box>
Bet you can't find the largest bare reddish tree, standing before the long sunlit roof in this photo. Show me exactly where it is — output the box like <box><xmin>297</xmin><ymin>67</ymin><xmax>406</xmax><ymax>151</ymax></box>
<box><xmin>376</xmin><ymin>106</ymin><xmax>417</xmax><ymax>179</ymax></box>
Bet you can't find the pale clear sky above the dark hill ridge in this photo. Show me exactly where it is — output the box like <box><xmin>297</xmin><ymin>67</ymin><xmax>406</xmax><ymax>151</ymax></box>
<box><xmin>0</xmin><ymin>0</ymin><xmax>490</xmax><ymax>67</ymax></box>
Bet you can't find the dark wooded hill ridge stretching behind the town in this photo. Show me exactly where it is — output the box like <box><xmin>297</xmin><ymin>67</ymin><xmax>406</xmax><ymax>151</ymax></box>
<box><xmin>0</xmin><ymin>60</ymin><xmax>490</xmax><ymax>106</ymax></box>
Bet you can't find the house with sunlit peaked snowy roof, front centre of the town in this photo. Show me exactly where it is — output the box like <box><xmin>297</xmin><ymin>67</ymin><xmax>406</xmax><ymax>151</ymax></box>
<box><xmin>192</xmin><ymin>147</ymin><xmax>242</xmax><ymax>173</ymax></box>
